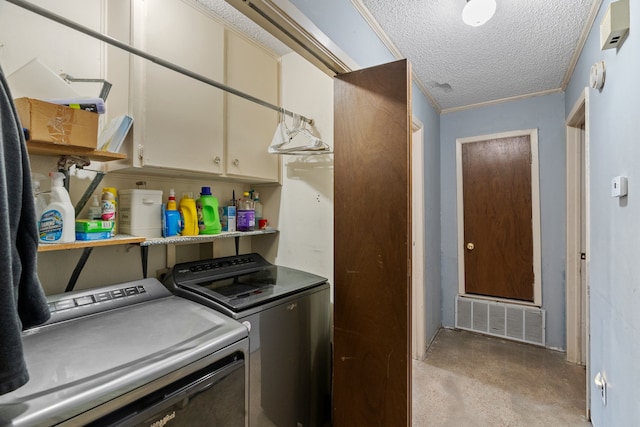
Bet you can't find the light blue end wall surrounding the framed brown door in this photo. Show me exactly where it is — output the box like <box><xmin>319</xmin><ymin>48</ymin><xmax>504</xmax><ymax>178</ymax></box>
<box><xmin>440</xmin><ymin>93</ymin><xmax>566</xmax><ymax>349</ymax></box>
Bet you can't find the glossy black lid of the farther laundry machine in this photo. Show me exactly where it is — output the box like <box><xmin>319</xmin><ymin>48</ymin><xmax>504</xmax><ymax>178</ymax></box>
<box><xmin>176</xmin><ymin>265</ymin><xmax>327</xmax><ymax>313</ymax></box>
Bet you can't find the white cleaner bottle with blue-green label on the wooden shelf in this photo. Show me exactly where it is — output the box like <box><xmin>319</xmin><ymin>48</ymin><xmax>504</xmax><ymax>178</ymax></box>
<box><xmin>38</xmin><ymin>172</ymin><xmax>76</xmax><ymax>243</ymax></box>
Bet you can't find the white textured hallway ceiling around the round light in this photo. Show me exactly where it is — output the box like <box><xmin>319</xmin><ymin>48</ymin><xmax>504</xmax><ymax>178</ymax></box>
<box><xmin>358</xmin><ymin>0</ymin><xmax>595</xmax><ymax>110</ymax></box>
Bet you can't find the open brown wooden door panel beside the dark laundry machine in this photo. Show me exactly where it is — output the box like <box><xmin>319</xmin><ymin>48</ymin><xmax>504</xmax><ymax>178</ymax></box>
<box><xmin>333</xmin><ymin>60</ymin><xmax>411</xmax><ymax>427</ymax></box>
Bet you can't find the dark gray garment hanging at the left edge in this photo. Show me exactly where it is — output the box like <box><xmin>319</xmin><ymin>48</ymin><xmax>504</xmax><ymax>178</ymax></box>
<box><xmin>0</xmin><ymin>67</ymin><xmax>50</xmax><ymax>394</ymax></box>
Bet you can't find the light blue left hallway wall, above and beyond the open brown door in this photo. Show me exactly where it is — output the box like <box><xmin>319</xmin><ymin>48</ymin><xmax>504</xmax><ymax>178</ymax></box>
<box><xmin>291</xmin><ymin>0</ymin><xmax>441</xmax><ymax>342</ymax></box>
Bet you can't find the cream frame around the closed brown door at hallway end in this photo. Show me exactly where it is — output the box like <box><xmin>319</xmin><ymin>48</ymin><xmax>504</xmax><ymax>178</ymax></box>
<box><xmin>456</xmin><ymin>129</ymin><xmax>542</xmax><ymax>307</ymax></box>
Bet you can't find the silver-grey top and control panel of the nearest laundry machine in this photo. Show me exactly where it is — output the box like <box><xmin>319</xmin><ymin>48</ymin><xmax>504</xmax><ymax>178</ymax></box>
<box><xmin>0</xmin><ymin>279</ymin><xmax>248</xmax><ymax>425</ymax></box>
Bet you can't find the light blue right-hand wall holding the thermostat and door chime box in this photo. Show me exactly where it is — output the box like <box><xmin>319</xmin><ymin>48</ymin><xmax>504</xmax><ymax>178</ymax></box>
<box><xmin>566</xmin><ymin>0</ymin><xmax>640</xmax><ymax>426</ymax></box>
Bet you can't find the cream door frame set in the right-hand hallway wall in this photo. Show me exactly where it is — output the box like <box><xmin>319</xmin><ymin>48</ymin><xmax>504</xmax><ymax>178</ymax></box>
<box><xmin>565</xmin><ymin>88</ymin><xmax>591</xmax><ymax>419</ymax></box>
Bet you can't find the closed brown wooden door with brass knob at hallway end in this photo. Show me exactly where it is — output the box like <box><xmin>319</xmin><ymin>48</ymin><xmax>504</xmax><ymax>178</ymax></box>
<box><xmin>462</xmin><ymin>135</ymin><xmax>534</xmax><ymax>302</ymax></box>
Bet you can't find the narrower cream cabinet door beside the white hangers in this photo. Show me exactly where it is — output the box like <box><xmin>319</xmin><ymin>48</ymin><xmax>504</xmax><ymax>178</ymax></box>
<box><xmin>226</xmin><ymin>31</ymin><xmax>280</xmax><ymax>182</ymax></box>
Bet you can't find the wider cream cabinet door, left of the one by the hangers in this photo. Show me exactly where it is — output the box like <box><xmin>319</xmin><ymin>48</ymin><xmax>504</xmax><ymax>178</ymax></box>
<box><xmin>131</xmin><ymin>0</ymin><xmax>224</xmax><ymax>174</ymax></box>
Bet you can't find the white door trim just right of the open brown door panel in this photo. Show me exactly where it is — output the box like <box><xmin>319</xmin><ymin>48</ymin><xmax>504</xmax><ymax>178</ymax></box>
<box><xmin>411</xmin><ymin>117</ymin><xmax>427</xmax><ymax>360</ymax></box>
